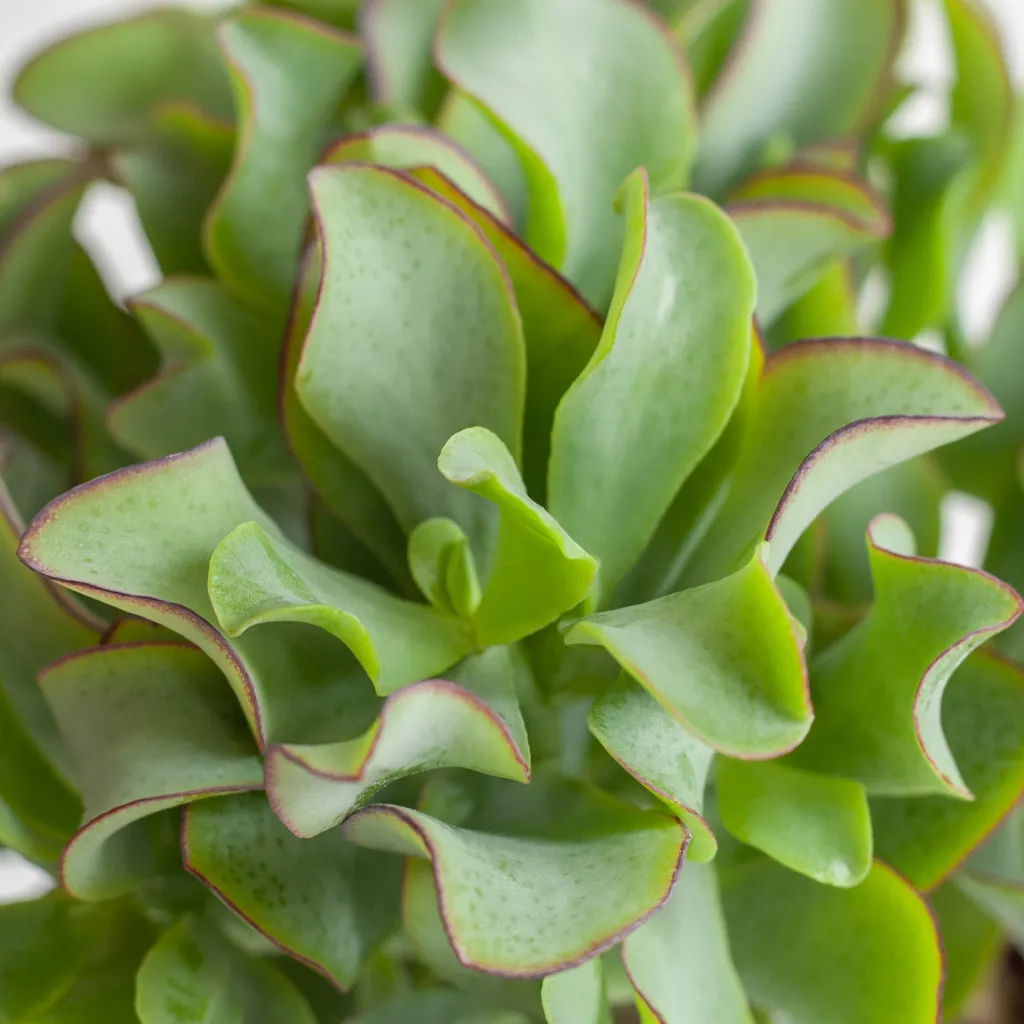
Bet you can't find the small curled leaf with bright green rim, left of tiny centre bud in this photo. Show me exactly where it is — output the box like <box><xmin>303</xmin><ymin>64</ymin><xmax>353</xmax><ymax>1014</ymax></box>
<box><xmin>210</xmin><ymin>522</ymin><xmax>469</xmax><ymax>694</ymax></box>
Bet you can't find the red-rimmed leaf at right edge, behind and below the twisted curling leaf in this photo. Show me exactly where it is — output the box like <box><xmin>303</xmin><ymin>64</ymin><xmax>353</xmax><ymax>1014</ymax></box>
<box><xmin>871</xmin><ymin>652</ymin><xmax>1024</xmax><ymax>890</ymax></box>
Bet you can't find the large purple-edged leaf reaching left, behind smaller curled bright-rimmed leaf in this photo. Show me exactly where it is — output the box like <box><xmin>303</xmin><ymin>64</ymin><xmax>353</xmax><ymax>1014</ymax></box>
<box><xmin>19</xmin><ymin>440</ymin><xmax>391</xmax><ymax>744</ymax></box>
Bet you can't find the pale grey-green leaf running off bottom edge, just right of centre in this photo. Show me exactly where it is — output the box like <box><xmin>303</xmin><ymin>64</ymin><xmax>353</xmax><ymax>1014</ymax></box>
<box><xmin>623</xmin><ymin>861</ymin><xmax>753</xmax><ymax>1024</ymax></box>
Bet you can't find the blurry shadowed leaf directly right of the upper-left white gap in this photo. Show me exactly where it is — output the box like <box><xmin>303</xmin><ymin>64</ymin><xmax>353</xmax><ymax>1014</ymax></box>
<box><xmin>113</xmin><ymin>102</ymin><xmax>234</xmax><ymax>274</ymax></box>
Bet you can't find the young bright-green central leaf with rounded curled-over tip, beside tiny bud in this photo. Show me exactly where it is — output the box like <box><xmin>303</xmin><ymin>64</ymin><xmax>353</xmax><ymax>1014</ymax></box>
<box><xmin>437</xmin><ymin>427</ymin><xmax>597</xmax><ymax>647</ymax></box>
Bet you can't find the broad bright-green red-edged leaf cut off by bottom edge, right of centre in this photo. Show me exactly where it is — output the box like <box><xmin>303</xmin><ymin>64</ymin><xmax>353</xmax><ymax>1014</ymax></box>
<box><xmin>722</xmin><ymin>858</ymin><xmax>942</xmax><ymax>1024</ymax></box>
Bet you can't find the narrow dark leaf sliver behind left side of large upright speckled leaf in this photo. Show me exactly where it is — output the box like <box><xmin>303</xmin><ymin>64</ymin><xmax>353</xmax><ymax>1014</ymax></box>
<box><xmin>279</xmin><ymin>244</ymin><xmax>413</xmax><ymax>591</ymax></box>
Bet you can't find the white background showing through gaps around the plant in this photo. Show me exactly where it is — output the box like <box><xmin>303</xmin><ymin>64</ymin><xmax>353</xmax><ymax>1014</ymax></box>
<box><xmin>0</xmin><ymin>0</ymin><xmax>1024</xmax><ymax>902</ymax></box>
